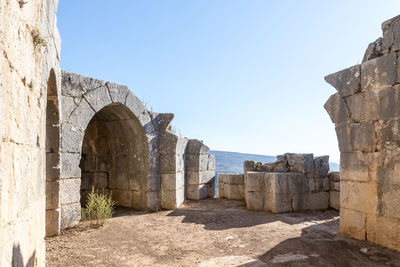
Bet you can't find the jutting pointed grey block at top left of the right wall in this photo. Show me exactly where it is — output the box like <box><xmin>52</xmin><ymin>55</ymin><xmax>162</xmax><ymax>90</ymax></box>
<box><xmin>325</xmin><ymin>65</ymin><xmax>361</xmax><ymax>97</ymax></box>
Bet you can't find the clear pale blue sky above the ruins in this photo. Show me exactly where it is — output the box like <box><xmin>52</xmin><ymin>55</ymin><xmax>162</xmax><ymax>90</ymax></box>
<box><xmin>58</xmin><ymin>0</ymin><xmax>400</xmax><ymax>162</ymax></box>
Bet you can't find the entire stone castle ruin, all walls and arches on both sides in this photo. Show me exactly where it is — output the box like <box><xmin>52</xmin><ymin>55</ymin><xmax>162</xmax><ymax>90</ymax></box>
<box><xmin>0</xmin><ymin>0</ymin><xmax>400</xmax><ymax>266</ymax></box>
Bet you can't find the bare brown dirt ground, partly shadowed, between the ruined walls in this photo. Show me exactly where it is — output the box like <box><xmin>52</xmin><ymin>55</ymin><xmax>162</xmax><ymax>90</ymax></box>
<box><xmin>46</xmin><ymin>199</ymin><xmax>400</xmax><ymax>267</ymax></box>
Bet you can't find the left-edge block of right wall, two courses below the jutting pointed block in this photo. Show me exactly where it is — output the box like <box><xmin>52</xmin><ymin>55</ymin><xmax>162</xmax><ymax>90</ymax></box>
<box><xmin>336</xmin><ymin>122</ymin><xmax>377</xmax><ymax>152</ymax></box>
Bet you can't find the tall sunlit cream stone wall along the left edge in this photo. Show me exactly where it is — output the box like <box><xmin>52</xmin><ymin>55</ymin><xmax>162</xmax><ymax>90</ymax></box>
<box><xmin>0</xmin><ymin>0</ymin><xmax>60</xmax><ymax>266</ymax></box>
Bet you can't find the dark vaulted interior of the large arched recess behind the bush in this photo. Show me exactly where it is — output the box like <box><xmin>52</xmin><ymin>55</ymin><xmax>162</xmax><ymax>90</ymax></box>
<box><xmin>80</xmin><ymin>103</ymin><xmax>149</xmax><ymax>209</ymax></box>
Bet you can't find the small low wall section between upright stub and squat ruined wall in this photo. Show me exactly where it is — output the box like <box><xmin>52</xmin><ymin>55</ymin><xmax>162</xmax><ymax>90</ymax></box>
<box><xmin>218</xmin><ymin>173</ymin><xmax>244</xmax><ymax>200</ymax></box>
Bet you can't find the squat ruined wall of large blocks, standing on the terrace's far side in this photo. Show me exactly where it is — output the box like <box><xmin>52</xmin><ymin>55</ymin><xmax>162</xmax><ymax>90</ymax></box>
<box><xmin>244</xmin><ymin>153</ymin><xmax>330</xmax><ymax>213</ymax></box>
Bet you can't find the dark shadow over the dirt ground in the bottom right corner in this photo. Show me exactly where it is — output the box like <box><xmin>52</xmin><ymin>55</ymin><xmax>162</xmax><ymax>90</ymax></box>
<box><xmin>241</xmin><ymin>219</ymin><xmax>400</xmax><ymax>267</ymax></box>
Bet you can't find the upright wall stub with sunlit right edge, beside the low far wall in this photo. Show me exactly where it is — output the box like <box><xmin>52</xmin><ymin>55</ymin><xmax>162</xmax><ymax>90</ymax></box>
<box><xmin>185</xmin><ymin>139</ymin><xmax>215</xmax><ymax>200</ymax></box>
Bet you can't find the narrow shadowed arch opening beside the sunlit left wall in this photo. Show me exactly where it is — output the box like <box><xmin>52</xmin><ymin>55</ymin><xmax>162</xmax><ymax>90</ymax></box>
<box><xmin>46</xmin><ymin>69</ymin><xmax>60</xmax><ymax>236</ymax></box>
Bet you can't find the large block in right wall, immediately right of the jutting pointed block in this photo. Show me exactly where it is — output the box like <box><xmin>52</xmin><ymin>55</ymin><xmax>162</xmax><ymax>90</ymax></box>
<box><xmin>361</xmin><ymin>53</ymin><xmax>397</xmax><ymax>91</ymax></box>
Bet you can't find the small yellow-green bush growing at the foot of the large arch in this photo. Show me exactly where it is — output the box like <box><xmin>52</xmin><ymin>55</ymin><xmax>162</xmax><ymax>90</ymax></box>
<box><xmin>82</xmin><ymin>186</ymin><xmax>116</xmax><ymax>226</ymax></box>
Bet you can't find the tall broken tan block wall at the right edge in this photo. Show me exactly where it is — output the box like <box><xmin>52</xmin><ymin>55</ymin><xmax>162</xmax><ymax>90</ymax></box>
<box><xmin>325</xmin><ymin>14</ymin><xmax>400</xmax><ymax>250</ymax></box>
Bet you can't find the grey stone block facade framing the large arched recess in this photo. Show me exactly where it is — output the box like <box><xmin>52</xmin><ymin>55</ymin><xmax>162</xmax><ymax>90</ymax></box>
<box><xmin>60</xmin><ymin>71</ymin><xmax>160</xmax><ymax>229</ymax></box>
